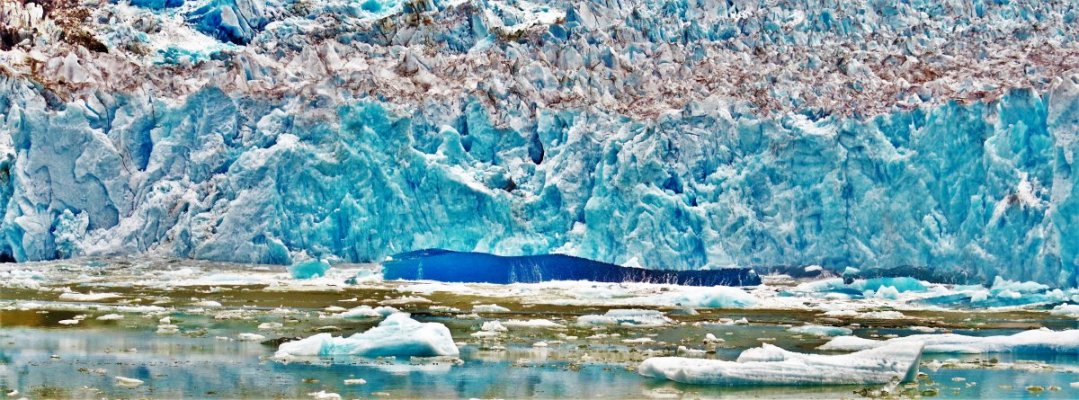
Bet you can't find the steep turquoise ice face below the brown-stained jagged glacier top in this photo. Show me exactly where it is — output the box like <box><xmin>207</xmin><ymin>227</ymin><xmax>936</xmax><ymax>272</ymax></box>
<box><xmin>0</xmin><ymin>78</ymin><xmax>1079</xmax><ymax>287</ymax></box>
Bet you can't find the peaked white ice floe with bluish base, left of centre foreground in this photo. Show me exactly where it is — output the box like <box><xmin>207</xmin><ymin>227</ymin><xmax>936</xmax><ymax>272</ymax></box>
<box><xmin>274</xmin><ymin>314</ymin><xmax>460</xmax><ymax>359</ymax></box>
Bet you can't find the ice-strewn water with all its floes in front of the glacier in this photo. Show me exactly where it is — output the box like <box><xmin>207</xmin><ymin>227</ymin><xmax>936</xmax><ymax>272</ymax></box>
<box><xmin>0</xmin><ymin>258</ymin><xmax>1079</xmax><ymax>398</ymax></box>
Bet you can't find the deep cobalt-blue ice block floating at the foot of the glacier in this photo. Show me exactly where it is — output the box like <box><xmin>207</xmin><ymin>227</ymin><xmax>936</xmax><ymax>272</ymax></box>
<box><xmin>382</xmin><ymin>249</ymin><xmax>761</xmax><ymax>286</ymax></box>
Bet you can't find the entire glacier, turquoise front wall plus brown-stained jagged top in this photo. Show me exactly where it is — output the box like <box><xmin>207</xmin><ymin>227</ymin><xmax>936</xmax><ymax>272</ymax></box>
<box><xmin>0</xmin><ymin>0</ymin><xmax>1079</xmax><ymax>287</ymax></box>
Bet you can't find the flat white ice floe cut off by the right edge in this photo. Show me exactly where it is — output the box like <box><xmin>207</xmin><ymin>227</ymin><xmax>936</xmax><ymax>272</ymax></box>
<box><xmin>818</xmin><ymin>329</ymin><xmax>1079</xmax><ymax>354</ymax></box>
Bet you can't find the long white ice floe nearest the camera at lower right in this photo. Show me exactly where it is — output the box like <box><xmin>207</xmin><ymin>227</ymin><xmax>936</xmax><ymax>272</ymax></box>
<box><xmin>638</xmin><ymin>343</ymin><xmax>921</xmax><ymax>386</ymax></box>
